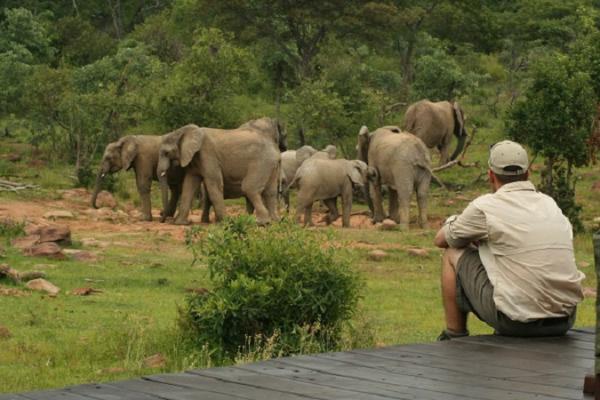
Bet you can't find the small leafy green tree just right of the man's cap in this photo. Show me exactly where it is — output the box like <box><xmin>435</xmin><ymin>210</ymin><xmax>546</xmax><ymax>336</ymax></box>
<box><xmin>507</xmin><ymin>54</ymin><xmax>595</xmax><ymax>228</ymax></box>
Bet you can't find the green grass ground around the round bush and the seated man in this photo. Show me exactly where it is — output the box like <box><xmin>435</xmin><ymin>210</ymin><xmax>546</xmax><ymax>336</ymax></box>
<box><xmin>0</xmin><ymin>127</ymin><xmax>600</xmax><ymax>392</ymax></box>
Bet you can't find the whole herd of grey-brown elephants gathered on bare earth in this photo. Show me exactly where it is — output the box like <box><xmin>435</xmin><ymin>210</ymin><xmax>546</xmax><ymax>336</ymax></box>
<box><xmin>92</xmin><ymin>100</ymin><xmax>467</xmax><ymax>229</ymax></box>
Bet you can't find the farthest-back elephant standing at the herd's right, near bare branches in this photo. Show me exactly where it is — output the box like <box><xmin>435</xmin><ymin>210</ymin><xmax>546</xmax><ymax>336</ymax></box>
<box><xmin>402</xmin><ymin>100</ymin><xmax>467</xmax><ymax>165</ymax></box>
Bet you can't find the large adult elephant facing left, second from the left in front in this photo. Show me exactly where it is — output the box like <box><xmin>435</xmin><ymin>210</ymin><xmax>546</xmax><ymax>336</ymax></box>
<box><xmin>157</xmin><ymin>119</ymin><xmax>285</xmax><ymax>225</ymax></box>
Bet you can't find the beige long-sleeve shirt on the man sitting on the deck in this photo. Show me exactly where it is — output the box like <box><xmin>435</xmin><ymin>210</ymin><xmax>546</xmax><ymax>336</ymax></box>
<box><xmin>445</xmin><ymin>181</ymin><xmax>585</xmax><ymax>322</ymax></box>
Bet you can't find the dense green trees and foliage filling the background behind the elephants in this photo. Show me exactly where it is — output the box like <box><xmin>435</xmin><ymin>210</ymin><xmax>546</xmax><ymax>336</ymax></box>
<box><xmin>0</xmin><ymin>0</ymin><xmax>600</xmax><ymax>219</ymax></box>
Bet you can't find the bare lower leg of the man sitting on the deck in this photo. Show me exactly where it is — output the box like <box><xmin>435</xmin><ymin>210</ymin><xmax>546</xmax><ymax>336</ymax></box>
<box><xmin>442</xmin><ymin>248</ymin><xmax>467</xmax><ymax>335</ymax></box>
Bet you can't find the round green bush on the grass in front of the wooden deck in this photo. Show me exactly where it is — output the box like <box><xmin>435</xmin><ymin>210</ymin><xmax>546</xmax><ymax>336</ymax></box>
<box><xmin>180</xmin><ymin>216</ymin><xmax>361</xmax><ymax>359</ymax></box>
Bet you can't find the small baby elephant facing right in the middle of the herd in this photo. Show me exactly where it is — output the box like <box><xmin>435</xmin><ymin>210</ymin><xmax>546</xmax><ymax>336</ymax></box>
<box><xmin>292</xmin><ymin>158</ymin><xmax>376</xmax><ymax>227</ymax></box>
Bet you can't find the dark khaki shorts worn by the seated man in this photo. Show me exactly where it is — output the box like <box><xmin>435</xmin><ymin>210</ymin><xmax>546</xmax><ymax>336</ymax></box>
<box><xmin>456</xmin><ymin>248</ymin><xmax>576</xmax><ymax>337</ymax></box>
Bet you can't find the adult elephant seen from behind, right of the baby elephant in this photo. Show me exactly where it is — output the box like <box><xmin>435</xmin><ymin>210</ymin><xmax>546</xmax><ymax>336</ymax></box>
<box><xmin>358</xmin><ymin>126</ymin><xmax>431</xmax><ymax>229</ymax></box>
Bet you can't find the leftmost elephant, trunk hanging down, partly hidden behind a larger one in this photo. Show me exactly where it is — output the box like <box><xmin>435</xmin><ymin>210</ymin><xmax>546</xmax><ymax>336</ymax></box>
<box><xmin>92</xmin><ymin>135</ymin><xmax>183</xmax><ymax>221</ymax></box>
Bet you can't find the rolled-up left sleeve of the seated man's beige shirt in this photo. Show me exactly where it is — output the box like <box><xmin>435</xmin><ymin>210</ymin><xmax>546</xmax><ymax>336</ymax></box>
<box><xmin>444</xmin><ymin>202</ymin><xmax>488</xmax><ymax>249</ymax></box>
